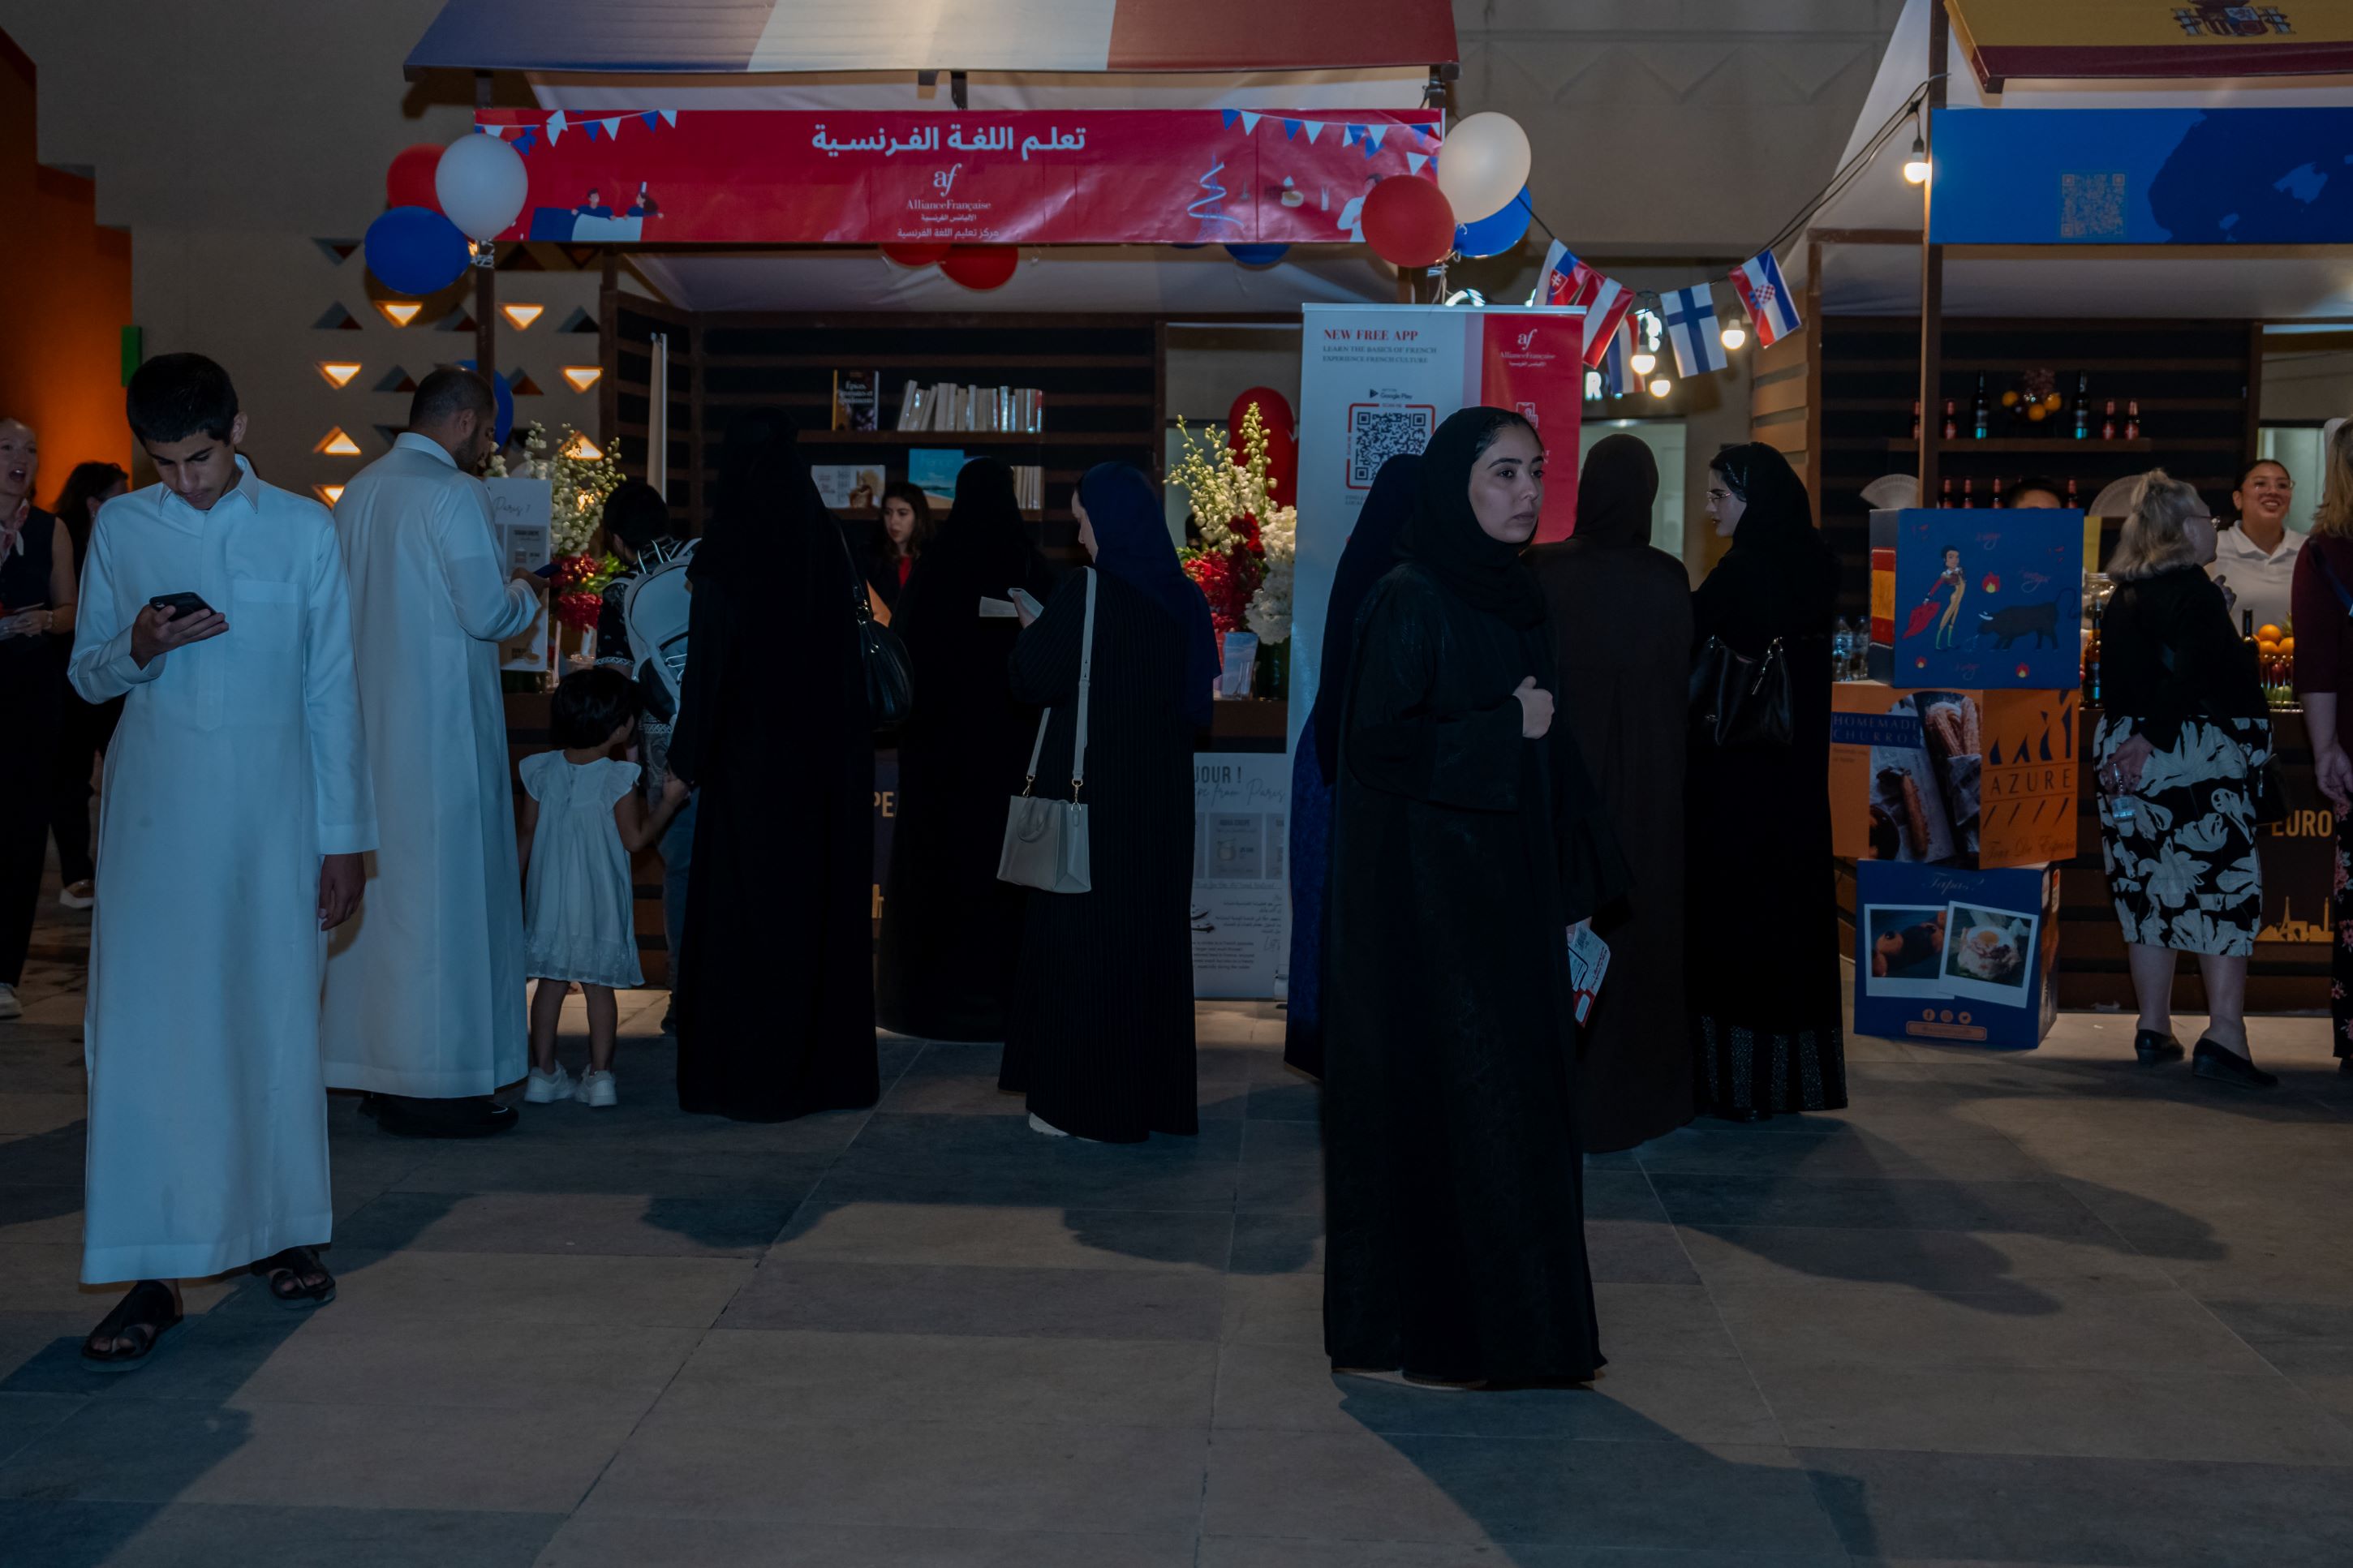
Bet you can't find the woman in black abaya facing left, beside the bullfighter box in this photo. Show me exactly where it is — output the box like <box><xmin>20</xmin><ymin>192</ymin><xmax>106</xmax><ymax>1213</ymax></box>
<box><xmin>1683</xmin><ymin>442</ymin><xmax>1848</xmax><ymax>1121</ymax></box>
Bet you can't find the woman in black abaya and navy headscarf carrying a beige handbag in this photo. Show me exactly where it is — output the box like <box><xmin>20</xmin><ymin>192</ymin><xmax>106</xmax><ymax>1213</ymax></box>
<box><xmin>998</xmin><ymin>463</ymin><xmax>1216</xmax><ymax>1142</ymax></box>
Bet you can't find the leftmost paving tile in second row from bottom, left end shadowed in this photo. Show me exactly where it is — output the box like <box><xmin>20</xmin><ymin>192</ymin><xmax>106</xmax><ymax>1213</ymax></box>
<box><xmin>0</xmin><ymin>1401</ymin><xmax>635</xmax><ymax>1514</ymax></box>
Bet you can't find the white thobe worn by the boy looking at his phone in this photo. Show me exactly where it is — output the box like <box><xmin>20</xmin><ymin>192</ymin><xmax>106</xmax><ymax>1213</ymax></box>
<box><xmin>73</xmin><ymin>458</ymin><xmax>376</xmax><ymax>1283</ymax></box>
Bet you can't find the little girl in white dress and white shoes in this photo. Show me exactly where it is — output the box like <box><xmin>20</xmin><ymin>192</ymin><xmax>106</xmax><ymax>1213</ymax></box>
<box><xmin>520</xmin><ymin>668</ymin><xmax>687</xmax><ymax>1105</ymax></box>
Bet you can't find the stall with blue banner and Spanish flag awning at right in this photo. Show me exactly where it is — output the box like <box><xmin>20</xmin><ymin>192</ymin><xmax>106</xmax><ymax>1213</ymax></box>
<box><xmin>1753</xmin><ymin>0</ymin><xmax>2353</xmax><ymax>1011</ymax></box>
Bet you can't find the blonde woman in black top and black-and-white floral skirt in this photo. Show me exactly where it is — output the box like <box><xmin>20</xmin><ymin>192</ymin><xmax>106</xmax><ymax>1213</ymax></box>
<box><xmin>2092</xmin><ymin>468</ymin><xmax>2278</xmax><ymax>1089</ymax></box>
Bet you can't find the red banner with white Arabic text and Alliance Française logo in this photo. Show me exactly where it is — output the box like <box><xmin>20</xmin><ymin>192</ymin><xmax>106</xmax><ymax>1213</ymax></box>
<box><xmin>475</xmin><ymin>108</ymin><xmax>1440</xmax><ymax>244</ymax></box>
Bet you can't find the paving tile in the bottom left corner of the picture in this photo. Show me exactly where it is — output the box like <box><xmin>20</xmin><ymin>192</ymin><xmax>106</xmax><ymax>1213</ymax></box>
<box><xmin>0</xmin><ymin>1502</ymin><xmax>562</xmax><ymax>1568</ymax></box>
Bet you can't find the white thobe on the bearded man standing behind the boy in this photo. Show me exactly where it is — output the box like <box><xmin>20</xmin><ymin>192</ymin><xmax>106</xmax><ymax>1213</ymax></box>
<box><xmin>325</xmin><ymin>435</ymin><xmax>539</xmax><ymax>1100</ymax></box>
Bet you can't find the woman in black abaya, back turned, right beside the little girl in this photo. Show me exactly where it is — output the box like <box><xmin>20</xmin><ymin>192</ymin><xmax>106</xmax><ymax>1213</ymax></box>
<box><xmin>671</xmin><ymin>409</ymin><xmax>880</xmax><ymax>1121</ymax></box>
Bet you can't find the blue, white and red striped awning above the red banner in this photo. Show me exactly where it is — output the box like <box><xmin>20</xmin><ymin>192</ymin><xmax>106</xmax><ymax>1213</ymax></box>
<box><xmin>407</xmin><ymin>0</ymin><xmax>1456</xmax><ymax>75</ymax></box>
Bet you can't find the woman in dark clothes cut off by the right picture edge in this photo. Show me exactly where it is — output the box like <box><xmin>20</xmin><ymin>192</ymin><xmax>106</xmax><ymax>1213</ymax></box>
<box><xmin>2295</xmin><ymin>423</ymin><xmax>2353</xmax><ymax>1072</ymax></box>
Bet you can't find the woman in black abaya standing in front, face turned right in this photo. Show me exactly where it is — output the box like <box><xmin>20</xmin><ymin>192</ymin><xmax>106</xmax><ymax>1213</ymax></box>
<box><xmin>1325</xmin><ymin>409</ymin><xmax>1626</xmax><ymax>1385</ymax></box>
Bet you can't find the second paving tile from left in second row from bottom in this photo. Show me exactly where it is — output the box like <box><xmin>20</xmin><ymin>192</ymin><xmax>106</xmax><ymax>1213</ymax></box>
<box><xmin>581</xmin><ymin>1413</ymin><xmax>1207</xmax><ymax>1535</ymax></box>
